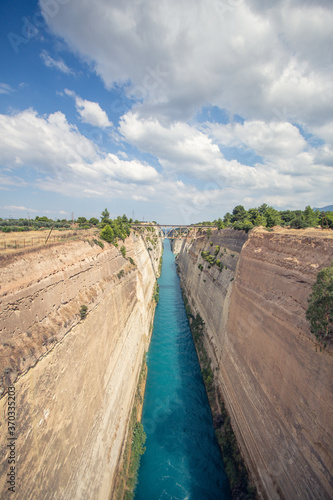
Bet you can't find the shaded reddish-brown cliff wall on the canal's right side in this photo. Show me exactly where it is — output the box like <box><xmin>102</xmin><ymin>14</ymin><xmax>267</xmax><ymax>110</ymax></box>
<box><xmin>178</xmin><ymin>229</ymin><xmax>333</xmax><ymax>500</ymax></box>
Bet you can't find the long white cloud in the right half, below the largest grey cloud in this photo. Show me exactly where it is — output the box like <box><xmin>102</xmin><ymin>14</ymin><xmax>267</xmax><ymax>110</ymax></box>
<box><xmin>119</xmin><ymin>112</ymin><xmax>332</xmax><ymax>206</ymax></box>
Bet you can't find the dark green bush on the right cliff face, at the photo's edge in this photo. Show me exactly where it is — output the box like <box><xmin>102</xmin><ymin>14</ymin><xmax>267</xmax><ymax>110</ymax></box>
<box><xmin>306</xmin><ymin>262</ymin><xmax>333</xmax><ymax>347</ymax></box>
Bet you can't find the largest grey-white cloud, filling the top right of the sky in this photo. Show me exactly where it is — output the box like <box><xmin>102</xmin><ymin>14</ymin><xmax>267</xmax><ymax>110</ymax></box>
<box><xmin>41</xmin><ymin>0</ymin><xmax>333</xmax><ymax>124</ymax></box>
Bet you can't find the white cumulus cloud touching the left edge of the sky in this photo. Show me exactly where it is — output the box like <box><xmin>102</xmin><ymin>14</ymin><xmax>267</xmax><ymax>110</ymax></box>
<box><xmin>0</xmin><ymin>109</ymin><xmax>158</xmax><ymax>195</ymax></box>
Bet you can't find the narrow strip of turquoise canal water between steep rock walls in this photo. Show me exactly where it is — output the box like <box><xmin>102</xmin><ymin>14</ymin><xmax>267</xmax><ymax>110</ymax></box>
<box><xmin>135</xmin><ymin>240</ymin><xmax>230</xmax><ymax>500</ymax></box>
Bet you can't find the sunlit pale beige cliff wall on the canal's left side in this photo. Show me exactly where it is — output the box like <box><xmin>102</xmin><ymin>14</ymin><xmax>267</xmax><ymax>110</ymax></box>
<box><xmin>0</xmin><ymin>234</ymin><xmax>162</xmax><ymax>499</ymax></box>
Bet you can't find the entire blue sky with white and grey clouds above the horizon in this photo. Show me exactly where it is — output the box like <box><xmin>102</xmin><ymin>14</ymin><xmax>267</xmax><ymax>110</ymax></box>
<box><xmin>0</xmin><ymin>0</ymin><xmax>333</xmax><ymax>224</ymax></box>
